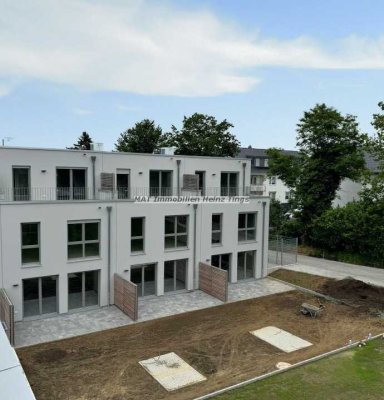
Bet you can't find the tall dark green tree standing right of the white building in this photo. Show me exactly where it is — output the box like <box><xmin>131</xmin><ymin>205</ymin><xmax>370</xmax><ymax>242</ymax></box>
<box><xmin>268</xmin><ymin>104</ymin><xmax>366</xmax><ymax>243</ymax></box>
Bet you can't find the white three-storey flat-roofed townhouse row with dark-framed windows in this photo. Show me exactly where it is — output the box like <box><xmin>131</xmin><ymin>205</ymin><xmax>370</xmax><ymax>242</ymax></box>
<box><xmin>0</xmin><ymin>147</ymin><xmax>269</xmax><ymax>320</ymax></box>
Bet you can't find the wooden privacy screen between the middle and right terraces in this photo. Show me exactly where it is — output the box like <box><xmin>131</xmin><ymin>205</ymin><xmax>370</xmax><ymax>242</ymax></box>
<box><xmin>199</xmin><ymin>262</ymin><xmax>228</xmax><ymax>301</ymax></box>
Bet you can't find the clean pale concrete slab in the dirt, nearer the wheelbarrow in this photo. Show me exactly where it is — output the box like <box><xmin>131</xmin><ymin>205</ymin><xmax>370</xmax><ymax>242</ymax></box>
<box><xmin>250</xmin><ymin>326</ymin><xmax>312</xmax><ymax>353</ymax></box>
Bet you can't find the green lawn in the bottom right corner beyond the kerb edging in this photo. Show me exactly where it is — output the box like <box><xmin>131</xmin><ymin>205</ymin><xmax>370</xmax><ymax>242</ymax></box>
<box><xmin>215</xmin><ymin>339</ymin><xmax>384</xmax><ymax>400</ymax></box>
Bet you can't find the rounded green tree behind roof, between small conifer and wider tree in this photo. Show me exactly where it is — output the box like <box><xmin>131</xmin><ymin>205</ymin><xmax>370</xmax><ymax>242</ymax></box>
<box><xmin>115</xmin><ymin>119</ymin><xmax>169</xmax><ymax>153</ymax></box>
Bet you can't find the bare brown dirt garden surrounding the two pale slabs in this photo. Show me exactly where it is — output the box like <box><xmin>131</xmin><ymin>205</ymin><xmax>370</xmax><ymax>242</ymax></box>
<box><xmin>17</xmin><ymin>277</ymin><xmax>384</xmax><ymax>400</ymax></box>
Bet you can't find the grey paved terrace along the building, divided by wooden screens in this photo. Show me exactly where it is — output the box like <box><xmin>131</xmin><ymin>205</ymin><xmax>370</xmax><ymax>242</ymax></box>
<box><xmin>15</xmin><ymin>278</ymin><xmax>292</xmax><ymax>347</ymax></box>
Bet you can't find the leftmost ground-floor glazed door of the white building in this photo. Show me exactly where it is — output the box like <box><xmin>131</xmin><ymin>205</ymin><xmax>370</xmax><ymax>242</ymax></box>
<box><xmin>23</xmin><ymin>276</ymin><xmax>59</xmax><ymax>318</ymax></box>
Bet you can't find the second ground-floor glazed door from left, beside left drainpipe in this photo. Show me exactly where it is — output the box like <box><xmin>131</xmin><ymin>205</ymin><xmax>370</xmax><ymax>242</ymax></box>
<box><xmin>68</xmin><ymin>271</ymin><xmax>99</xmax><ymax>310</ymax></box>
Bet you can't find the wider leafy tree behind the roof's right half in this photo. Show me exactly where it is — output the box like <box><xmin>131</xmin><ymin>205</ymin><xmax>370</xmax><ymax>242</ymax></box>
<box><xmin>171</xmin><ymin>113</ymin><xmax>240</xmax><ymax>157</ymax></box>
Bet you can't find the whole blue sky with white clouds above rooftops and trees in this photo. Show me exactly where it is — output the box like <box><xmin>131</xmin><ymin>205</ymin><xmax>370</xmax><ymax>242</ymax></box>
<box><xmin>0</xmin><ymin>0</ymin><xmax>384</xmax><ymax>150</ymax></box>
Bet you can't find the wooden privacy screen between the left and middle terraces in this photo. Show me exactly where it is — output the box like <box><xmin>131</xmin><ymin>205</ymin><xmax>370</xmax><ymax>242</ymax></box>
<box><xmin>114</xmin><ymin>274</ymin><xmax>139</xmax><ymax>321</ymax></box>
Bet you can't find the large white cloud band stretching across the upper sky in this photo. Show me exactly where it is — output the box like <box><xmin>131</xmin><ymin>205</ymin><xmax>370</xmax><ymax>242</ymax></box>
<box><xmin>0</xmin><ymin>0</ymin><xmax>384</xmax><ymax>96</ymax></box>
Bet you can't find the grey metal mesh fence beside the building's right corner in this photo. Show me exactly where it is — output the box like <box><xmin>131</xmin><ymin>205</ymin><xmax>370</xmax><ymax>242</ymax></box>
<box><xmin>268</xmin><ymin>235</ymin><xmax>298</xmax><ymax>265</ymax></box>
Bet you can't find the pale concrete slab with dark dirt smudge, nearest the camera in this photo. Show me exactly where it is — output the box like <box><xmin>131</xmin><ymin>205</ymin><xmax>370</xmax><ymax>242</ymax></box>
<box><xmin>139</xmin><ymin>352</ymin><xmax>207</xmax><ymax>392</ymax></box>
